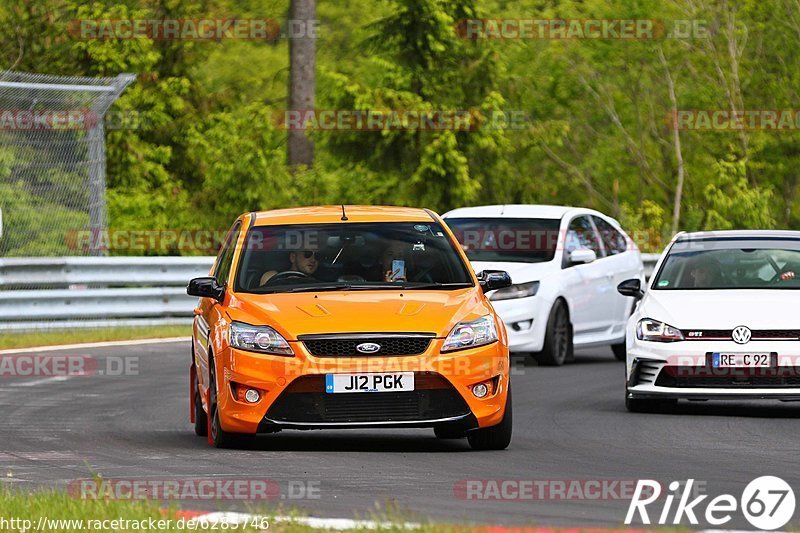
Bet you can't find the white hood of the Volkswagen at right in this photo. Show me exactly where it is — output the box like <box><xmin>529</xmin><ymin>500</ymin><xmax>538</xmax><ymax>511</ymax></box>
<box><xmin>639</xmin><ymin>289</ymin><xmax>800</xmax><ymax>329</ymax></box>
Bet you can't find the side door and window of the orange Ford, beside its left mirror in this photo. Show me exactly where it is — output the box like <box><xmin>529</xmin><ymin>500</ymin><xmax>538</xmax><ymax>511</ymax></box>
<box><xmin>192</xmin><ymin>221</ymin><xmax>241</xmax><ymax>397</ymax></box>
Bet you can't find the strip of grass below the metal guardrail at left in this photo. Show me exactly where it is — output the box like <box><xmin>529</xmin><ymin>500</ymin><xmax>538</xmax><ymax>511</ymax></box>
<box><xmin>0</xmin><ymin>324</ymin><xmax>192</xmax><ymax>350</ymax></box>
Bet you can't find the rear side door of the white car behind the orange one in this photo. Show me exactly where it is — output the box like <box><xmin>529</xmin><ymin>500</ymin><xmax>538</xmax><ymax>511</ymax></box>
<box><xmin>592</xmin><ymin>215</ymin><xmax>641</xmax><ymax>336</ymax></box>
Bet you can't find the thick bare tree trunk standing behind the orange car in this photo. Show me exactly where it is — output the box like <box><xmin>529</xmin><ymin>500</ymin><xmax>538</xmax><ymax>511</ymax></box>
<box><xmin>287</xmin><ymin>0</ymin><xmax>317</xmax><ymax>168</ymax></box>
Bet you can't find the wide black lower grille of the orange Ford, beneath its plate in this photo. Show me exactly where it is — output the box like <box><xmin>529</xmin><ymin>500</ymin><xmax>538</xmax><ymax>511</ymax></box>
<box><xmin>265</xmin><ymin>372</ymin><xmax>469</xmax><ymax>424</ymax></box>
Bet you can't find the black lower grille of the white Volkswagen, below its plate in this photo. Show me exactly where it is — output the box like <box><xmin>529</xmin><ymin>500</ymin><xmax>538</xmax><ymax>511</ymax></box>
<box><xmin>656</xmin><ymin>366</ymin><xmax>800</xmax><ymax>389</ymax></box>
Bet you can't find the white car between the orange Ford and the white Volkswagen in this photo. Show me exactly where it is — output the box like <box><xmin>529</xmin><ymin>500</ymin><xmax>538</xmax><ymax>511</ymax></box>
<box><xmin>444</xmin><ymin>205</ymin><xmax>644</xmax><ymax>365</ymax></box>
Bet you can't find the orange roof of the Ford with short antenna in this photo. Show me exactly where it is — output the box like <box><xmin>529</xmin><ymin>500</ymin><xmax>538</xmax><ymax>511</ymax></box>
<box><xmin>254</xmin><ymin>205</ymin><xmax>436</xmax><ymax>226</ymax></box>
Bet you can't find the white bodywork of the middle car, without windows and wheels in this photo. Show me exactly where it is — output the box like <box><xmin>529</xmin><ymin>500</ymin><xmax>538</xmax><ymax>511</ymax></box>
<box><xmin>443</xmin><ymin>205</ymin><xmax>644</xmax><ymax>352</ymax></box>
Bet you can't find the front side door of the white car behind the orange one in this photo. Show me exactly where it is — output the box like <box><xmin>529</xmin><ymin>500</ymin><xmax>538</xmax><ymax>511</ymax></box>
<box><xmin>562</xmin><ymin>215</ymin><xmax>614</xmax><ymax>344</ymax></box>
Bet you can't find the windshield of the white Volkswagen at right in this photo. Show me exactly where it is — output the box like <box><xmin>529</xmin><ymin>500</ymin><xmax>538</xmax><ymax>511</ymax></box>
<box><xmin>653</xmin><ymin>239</ymin><xmax>800</xmax><ymax>290</ymax></box>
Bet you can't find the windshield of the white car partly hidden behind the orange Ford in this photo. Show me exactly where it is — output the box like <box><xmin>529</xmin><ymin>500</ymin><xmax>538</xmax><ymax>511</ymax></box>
<box><xmin>446</xmin><ymin>218</ymin><xmax>561</xmax><ymax>263</ymax></box>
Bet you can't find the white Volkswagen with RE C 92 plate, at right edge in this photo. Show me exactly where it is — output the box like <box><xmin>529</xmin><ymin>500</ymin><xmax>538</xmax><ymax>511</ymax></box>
<box><xmin>619</xmin><ymin>231</ymin><xmax>800</xmax><ymax>411</ymax></box>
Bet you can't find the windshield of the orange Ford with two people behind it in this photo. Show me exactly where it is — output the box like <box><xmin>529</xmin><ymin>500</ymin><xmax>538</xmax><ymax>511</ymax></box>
<box><xmin>231</xmin><ymin>222</ymin><xmax>473</xmax><ymax>293</ymax></box>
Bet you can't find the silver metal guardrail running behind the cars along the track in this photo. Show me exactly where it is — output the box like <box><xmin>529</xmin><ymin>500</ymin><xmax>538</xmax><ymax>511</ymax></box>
<box><xmin>0</xmin><ymin>254</ymin><xmax>659</xmax><ymax>331</ymax></box>
